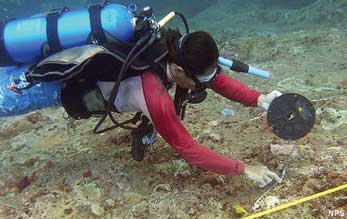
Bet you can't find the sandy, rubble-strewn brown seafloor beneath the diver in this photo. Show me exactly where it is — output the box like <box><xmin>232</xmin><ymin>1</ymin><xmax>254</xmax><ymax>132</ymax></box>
<box><xmin>0</xmin><ymin>1</ymin><xmax>347</xmax><ymax>219</ymax></box>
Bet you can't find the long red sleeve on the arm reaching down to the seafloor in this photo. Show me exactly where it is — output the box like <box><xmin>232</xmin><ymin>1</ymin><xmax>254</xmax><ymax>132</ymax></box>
<box><xmin>141</xmin><ymin>71</ymin><xmax>244</xmax><ymax>176</ymax></box>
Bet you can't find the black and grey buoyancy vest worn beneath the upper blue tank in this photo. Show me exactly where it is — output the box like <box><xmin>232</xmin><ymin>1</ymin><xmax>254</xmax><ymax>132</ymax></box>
<box><xmin>26</xmin><ymin>29</ymin><xmax>171</xmax><ymax>119</ymax></box>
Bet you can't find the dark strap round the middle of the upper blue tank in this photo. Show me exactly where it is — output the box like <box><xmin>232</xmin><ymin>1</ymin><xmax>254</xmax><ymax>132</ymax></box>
<box><xmin>46</xmin><ymin>7</ymin><xmax>69</xmax><ymax>54</ymax></box>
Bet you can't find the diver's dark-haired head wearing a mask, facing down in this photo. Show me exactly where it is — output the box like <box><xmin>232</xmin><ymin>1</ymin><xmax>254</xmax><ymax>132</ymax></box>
<box><xmin>167</xmin><ymin>31</ymin><xmax>219</xmax><ymax>89</ymax></box>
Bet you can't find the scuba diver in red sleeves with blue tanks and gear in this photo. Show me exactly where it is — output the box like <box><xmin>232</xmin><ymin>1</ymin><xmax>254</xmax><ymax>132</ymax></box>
<box><xmin>0</xmin><ymin>3</ymin><xmax>282</xmax><ymax>187</ymax></box>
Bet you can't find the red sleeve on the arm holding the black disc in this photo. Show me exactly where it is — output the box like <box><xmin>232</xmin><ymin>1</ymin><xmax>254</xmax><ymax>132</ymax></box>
<box><xmin>211</xmin><ymin>74</ymin><xmax>260</xmax><ymax>107</ymax></box>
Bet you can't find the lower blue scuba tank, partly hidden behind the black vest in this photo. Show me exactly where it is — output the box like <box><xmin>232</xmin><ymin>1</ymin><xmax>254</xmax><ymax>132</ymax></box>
<box><xmin>0</xmin><ymin>66</ymin><xmax>64</xmax><ymax>117</ymax></box>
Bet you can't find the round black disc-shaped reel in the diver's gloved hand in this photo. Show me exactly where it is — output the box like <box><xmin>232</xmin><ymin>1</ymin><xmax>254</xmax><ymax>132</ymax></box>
<box><xmin>267</xmin><ymin>93</ymin><xmax>316</xmax><ymax>140</ymax></box>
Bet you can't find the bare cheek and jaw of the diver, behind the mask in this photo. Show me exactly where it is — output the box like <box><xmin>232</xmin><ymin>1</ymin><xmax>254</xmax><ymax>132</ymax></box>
<box><xmin>169</xmin><ymin>63</ymin><xmax>195</xmax><ymax>90</ymax></box>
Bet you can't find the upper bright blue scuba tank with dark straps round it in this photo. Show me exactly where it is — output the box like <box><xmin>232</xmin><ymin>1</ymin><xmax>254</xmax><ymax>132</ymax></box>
<box><xmin>0</xmin><ymin>2</ymin><xmax>135</xmax><ymax>66</ymax></box>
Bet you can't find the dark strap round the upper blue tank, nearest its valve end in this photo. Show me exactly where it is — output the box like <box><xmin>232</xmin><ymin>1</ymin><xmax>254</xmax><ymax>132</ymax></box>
<box><xmin>88</xmin><ymin>1</ymin><xmax>110</xmax><ymax>44</ymax></box>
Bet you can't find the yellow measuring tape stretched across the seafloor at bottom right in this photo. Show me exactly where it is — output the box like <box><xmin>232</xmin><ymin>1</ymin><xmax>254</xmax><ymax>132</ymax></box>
<box><xmin>242</xmin><ymin>184</ymin><xmax>347</xmax><ymax>219</ymax></box>
